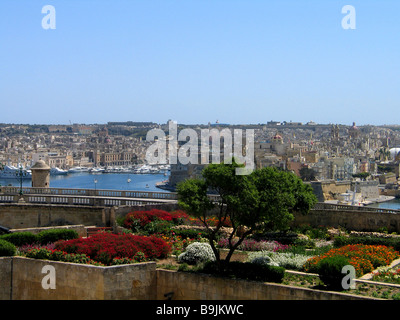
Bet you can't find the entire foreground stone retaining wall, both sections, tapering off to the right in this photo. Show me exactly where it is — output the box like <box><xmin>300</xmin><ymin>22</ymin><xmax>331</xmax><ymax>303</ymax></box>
<box><xmin>0</xmin><ymin>257</ymin><xmax>376</xmax><ymax>300</ymax></box>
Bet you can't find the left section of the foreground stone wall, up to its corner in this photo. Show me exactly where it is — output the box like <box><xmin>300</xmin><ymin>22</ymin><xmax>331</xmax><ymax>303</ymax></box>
<box><xmin>0</xmin><ymin>257</ymin><xmax>156</xmax><ymax>300</ymax></box>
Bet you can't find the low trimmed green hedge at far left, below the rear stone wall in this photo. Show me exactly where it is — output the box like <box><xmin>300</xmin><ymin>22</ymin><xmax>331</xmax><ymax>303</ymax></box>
<box><xmin>0</xmin><ymin>229</ymin><xmax>78</xmax><ymax>247</ymax></box>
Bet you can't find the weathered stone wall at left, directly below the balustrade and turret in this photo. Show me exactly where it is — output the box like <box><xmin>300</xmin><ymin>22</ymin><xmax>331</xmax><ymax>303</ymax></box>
<box><xmin>0</xmin><ymin>203</ymin><xmax>112</xmax><ymax>229</ymax></box>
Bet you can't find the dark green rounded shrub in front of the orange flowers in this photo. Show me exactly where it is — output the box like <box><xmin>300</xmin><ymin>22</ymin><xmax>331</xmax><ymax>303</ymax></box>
<box><xmin>316</xmin><ymin>256</ymin><xmax>349</xmax><ymax>290</ymax></box>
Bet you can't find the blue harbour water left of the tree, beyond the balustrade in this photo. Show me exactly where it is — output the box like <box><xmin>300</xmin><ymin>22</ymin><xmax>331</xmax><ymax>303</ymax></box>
<box><xmin>0</xmin><ymin>172</ymin><xmax>169</xmax><ymax>192</ymax></box>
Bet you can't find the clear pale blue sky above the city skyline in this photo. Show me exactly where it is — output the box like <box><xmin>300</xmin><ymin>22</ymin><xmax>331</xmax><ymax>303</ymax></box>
<box><xmin>0</xmin><ymin>0</ymin><xmax>400</xmax><ymax>125</ymax></box>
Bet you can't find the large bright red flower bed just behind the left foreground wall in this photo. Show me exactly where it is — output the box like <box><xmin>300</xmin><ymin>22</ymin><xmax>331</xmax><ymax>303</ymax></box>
<box><xmin>55</xmin><ymin>233</ymin><xmax>171</xmax><ymax>265</ymax></box>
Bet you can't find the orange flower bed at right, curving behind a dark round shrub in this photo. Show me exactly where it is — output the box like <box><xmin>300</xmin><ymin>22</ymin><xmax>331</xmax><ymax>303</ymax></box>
<box><xmin>305</xmin><ymin>244</ymin><xmax>400</xmax><ymax>277</ymax></box>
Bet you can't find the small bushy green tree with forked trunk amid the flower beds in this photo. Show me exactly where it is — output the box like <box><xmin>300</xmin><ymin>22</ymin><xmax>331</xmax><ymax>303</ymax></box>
<box><xmin>177</xmin><ymin>161</ymin><xmax>317</xmax><ymax>269</ymax></box>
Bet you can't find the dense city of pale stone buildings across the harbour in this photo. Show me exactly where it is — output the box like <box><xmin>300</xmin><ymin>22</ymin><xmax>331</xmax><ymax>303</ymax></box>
<box><xmin>0</xmin><ymin>121</ymin><xmax>400</xmax><ymax>203</ymax></box>
